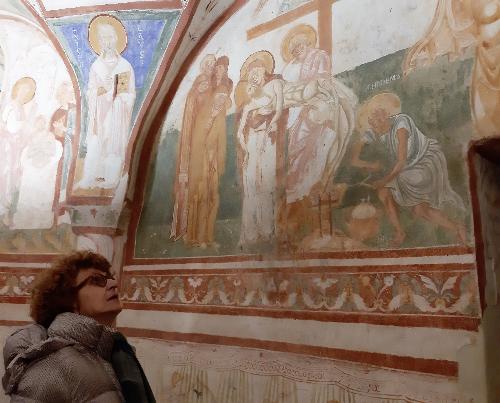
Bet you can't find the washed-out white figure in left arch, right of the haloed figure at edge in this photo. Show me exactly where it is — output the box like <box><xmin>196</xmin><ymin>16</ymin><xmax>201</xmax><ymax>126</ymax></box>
<box><xmin>11</xmin><ymin>116</ymin><xmax>63</xmax><ymax>229</ymax></box>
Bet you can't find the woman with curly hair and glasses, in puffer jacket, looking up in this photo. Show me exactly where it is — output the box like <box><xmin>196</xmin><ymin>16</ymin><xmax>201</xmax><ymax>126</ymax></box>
<box><xmin>2</xmin><ymin>251</ymin><xmax>155</xmax><ymax>403</ymax></box>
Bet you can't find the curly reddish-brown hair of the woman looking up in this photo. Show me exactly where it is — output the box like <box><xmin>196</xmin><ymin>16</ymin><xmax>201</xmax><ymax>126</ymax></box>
<box><xmin>30</xmin><ymin>251</ymin><xmax>111</xmax><ymax>327</ymax></box>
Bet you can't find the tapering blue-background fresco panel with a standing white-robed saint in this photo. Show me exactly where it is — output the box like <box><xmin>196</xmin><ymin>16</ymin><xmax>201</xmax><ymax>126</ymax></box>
<box><xmin>51</xmin><ymin>10</ymin><xmax>180</xmax><ymax>198</ymax></box>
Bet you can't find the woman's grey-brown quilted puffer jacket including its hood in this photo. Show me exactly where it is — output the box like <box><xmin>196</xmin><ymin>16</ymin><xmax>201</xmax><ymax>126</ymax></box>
<box><xmin>2</xmin><ymin>312</ymin><xmax>124</xmax><ymax>403</ymax></box>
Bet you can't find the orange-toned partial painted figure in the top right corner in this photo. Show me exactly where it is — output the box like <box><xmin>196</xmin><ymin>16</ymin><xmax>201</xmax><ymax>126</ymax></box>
<box><xmin>403</xmin><ymin>0</ymin><xmax>500</xmax><ymax>136</ymax></box>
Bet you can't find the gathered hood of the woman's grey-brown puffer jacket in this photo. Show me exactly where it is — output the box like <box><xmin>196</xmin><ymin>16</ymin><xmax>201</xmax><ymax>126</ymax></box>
<box><xmin>2</xmin><ymin>312</ymin><xmax>113</xmax><ymax>394</ymax></box>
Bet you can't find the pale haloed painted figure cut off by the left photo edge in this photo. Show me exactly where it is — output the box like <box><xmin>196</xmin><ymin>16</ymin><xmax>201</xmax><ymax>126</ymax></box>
<box><xmin>0</xmin><ymin>77</ymin><xmax>36</xmax><ymax>226</ymax></box>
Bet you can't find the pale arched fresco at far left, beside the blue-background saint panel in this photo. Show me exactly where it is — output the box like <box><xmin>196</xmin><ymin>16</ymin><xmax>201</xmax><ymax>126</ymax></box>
<box><xmin>0</xmin><ymin>12</ymin><xmax>75</xmax><ymax>253</ymax></box>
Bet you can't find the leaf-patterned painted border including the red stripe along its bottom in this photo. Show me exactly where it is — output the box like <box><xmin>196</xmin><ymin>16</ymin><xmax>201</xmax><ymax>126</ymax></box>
<box><xmin>121</xmin><ymin>264</ymin><xmax>480</xmax><ymax>330</ymax></box>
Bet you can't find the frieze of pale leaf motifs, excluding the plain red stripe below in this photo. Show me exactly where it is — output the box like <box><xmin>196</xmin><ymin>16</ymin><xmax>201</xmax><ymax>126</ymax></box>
<box><xmin>122</xmin><ymin>269</ymin><xmax>479</xmax><ymax>317</ymax></box>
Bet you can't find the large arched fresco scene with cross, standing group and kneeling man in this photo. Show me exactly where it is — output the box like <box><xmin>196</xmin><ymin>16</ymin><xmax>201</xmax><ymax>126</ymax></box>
<box><xmin>135</xmin><ymin>0</ymin><xmax>484</xmax><ymax>258</ymax></box>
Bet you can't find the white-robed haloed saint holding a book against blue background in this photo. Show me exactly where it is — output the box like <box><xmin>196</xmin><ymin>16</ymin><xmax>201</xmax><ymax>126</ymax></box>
<box><xmin>77</xmin><ymin>15</ymin><xmax>135</xmax><ymax>189</ymax></box>
